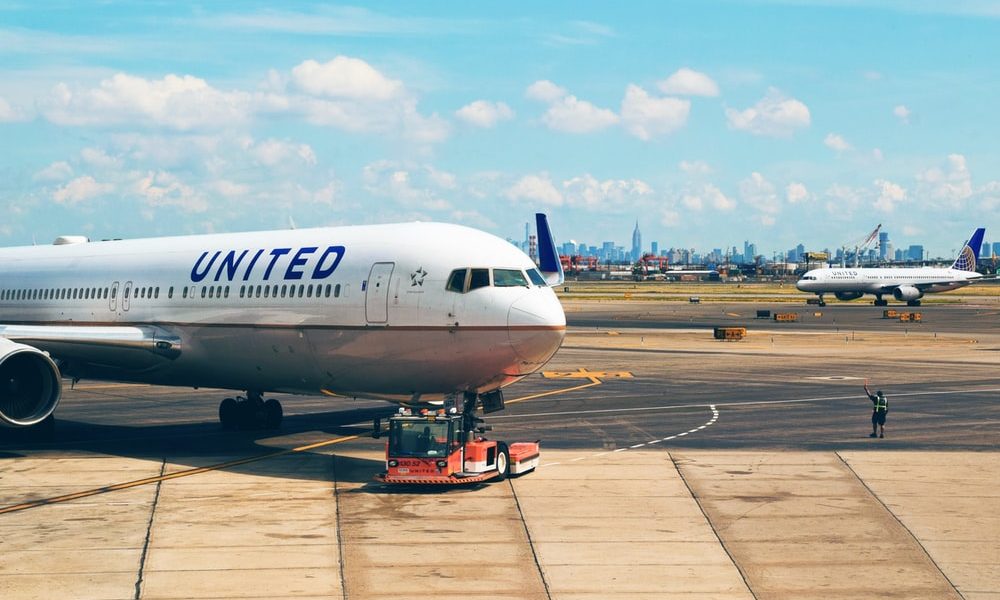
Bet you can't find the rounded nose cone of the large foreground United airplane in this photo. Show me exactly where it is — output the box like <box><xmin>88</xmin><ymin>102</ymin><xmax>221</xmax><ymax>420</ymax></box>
<box><xmin>507</xmin><ymin>289</ymin><xmax>566</xmax><ymax>373</ymax></box>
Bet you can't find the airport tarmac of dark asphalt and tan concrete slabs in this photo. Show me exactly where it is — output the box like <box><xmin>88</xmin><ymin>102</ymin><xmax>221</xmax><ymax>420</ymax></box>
<box><xmin>0</xmin><ymin>303</ymin><xmax>1000</xmax><ymax>600</ymax></box>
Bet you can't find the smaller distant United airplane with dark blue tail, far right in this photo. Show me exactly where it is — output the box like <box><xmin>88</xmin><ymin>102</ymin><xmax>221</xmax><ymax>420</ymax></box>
<box><xmin>795</xmin><ymin>228</ymin><xmax>986</xmax><ymax>306</ymax></box>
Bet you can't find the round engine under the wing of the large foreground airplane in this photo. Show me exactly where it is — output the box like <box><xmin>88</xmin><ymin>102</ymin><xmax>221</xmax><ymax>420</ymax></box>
<box><xmin>0</xmin><ymin>338</ymin><xmax>62</xmax><ymax>427</ymax></box>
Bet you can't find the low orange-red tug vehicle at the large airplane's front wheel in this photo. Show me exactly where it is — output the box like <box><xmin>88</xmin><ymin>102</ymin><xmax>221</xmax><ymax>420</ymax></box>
<box><xmin>375</xmin><ymin>411</ymin><xmax>539</xmax><ymax>485</ymax></box>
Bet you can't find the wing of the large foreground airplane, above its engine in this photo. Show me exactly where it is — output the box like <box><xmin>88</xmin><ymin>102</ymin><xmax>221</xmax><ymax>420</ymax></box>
<box><xmin>0</xmin><ymin>325</ymin><xmax>181</xmax><ymax>367</ymax></box>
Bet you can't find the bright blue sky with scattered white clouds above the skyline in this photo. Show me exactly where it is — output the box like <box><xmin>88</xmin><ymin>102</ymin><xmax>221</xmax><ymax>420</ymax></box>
<box><xmin>0</xmin><ymin>0</ymin><xmax>1000</xmax><ymax>256</ymax></box>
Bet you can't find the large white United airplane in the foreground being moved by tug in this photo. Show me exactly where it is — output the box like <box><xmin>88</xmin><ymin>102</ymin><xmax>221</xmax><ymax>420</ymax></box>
<box><xmin>0</xmin><ymin>214</ymin><xmax>566</xmax><ymax>429</ymax></box>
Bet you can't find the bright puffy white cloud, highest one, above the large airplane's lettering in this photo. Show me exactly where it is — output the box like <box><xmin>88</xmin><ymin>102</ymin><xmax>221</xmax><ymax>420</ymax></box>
<box><xmin>292</xmin><ymin>56</ymin><xmax>403</xmax><ymax>101</ymax></box>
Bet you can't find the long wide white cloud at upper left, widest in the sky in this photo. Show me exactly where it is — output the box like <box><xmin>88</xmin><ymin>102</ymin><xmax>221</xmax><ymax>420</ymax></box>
<box><xmin>41</xmin><ymin>73</ymin><xmax>252</xmax><ymax>131</ymax></box>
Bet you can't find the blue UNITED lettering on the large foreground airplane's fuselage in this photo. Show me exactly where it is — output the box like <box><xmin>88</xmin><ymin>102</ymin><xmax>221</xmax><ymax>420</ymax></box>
<box><xmin>191</xmin><ymin>246</ymin><xmax>345</xmax><ymax>283</ymax></box>
